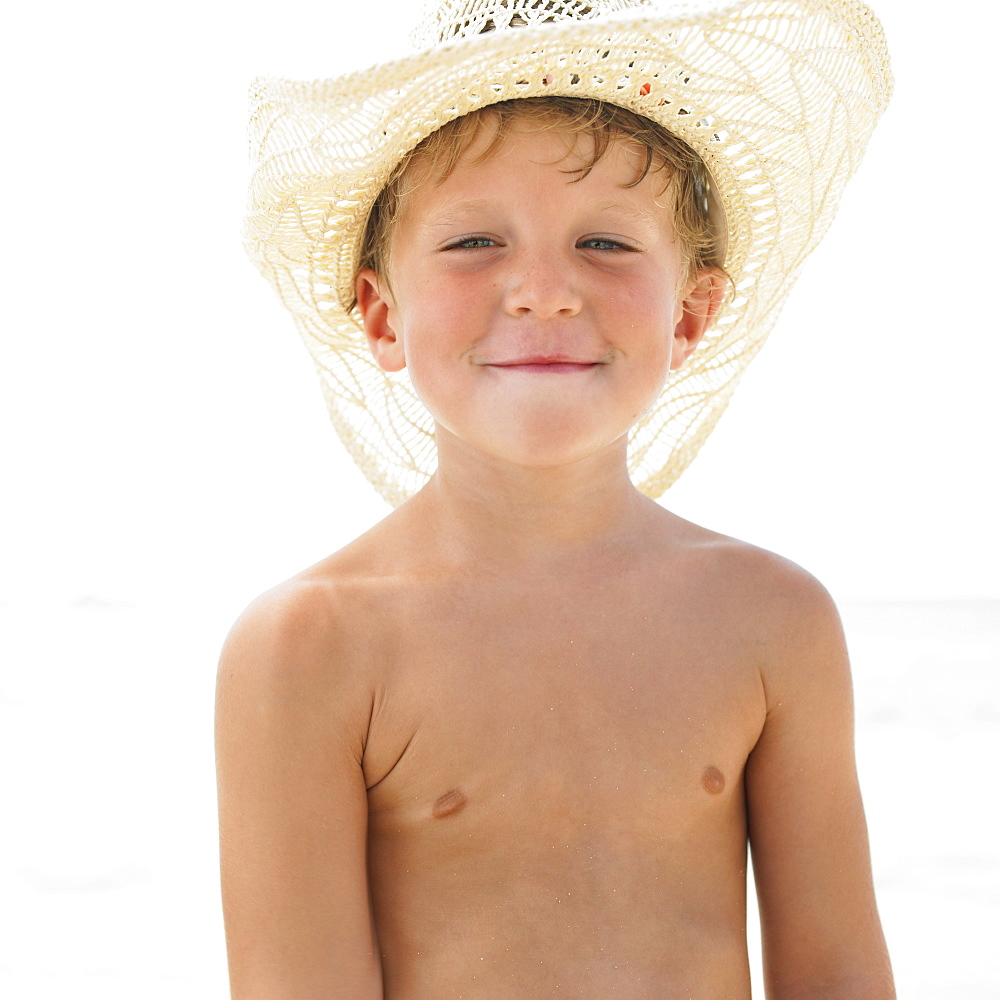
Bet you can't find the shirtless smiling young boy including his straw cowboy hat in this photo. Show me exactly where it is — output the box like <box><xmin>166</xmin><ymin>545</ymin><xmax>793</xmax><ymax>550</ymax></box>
<box><xmin>218</xmin><ymin>0</ymin><xmax>894</xmax><ymax>1000</ymax></box>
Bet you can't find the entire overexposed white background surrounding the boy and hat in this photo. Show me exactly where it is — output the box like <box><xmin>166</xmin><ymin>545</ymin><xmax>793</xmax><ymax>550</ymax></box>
<box><xmin>0</xmin><ymin>0</ymin><xmax>1000</xmax><ymax>998</ymax></box>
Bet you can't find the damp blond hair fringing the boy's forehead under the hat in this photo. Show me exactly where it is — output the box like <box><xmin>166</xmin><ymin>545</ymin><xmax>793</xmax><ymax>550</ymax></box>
<box><xmin>358</xmin><ymin>97</ymin><xmax>723</xmax><ymax>300</ymax></box>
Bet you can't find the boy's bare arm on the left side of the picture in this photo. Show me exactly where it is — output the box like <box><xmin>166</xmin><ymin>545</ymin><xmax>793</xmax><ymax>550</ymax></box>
<box><xmin>216</xmin><ymin>584</ymin><xmax>382</xmax><ymax>1000</ymax></box>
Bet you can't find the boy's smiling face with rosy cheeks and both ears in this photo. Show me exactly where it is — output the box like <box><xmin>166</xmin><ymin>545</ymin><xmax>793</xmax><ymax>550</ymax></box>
<box><xmin>357</xmin><ymin>124</ymin><xmax>721</xmax><ymax>476</ymax></box>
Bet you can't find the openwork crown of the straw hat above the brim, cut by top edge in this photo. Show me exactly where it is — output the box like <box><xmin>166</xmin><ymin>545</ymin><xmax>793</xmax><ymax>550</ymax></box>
<box><xmin>411</xmin><ymin>0</ymin><xmax>650</xmax><ymax>49</ymax></box>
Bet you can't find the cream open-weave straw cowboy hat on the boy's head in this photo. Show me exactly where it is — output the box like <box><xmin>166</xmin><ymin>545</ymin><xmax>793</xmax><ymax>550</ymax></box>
<box><xmin>244</xmin><ymin>0</ymin><xmax>892</xmax><ymax>504</ymax></box>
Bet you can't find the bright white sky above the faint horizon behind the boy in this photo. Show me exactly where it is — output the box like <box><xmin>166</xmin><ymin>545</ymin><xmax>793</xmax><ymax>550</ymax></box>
<box><xmin>0</xmin><ymin>0</ymin><xmax>1000</xmax><ymax>609</ymax></box>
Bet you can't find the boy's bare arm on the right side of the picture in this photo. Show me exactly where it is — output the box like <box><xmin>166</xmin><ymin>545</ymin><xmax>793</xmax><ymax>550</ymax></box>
<box><xmin>746</xmin><ymin>569</ymin><xmax>895</xmax><ymax>1000</ymax></box>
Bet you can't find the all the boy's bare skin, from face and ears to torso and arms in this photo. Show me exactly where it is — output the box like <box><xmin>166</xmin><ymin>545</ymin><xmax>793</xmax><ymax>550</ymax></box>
<box><xmin>217</xmin><ymin>121</ymin><xmax>894</xmax><ymax>1000</ymax></box>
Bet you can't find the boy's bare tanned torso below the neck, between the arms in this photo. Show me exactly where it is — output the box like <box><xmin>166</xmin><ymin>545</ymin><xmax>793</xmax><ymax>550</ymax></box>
<box><xmin>313</xmin><ymin>508</ymin><xmax>766</xmax><ymax>1000</ymax></box>
